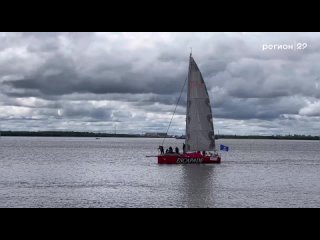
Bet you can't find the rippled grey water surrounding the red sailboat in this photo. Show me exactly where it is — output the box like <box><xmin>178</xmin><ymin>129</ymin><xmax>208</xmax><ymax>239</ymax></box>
<box><xmin>0</xmin><ymin>137</ymin><xmax>320</xmax><ymax>208</ymax></box>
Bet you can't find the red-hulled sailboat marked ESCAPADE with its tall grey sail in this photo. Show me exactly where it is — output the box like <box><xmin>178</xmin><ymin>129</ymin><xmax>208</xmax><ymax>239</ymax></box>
<box><xmin>157</xmin><ymin>53</ymin><xmax>221</xmax><ymax>164</ymax></box>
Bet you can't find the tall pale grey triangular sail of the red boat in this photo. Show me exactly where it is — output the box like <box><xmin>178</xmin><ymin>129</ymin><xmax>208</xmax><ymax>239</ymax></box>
<box><xmin>186</xmin><ymin>55</ymin><xmax>215</xmax><ymax>151</ymax></box>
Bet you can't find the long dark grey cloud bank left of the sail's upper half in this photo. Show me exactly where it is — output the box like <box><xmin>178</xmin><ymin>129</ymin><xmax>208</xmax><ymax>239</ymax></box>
<box><xmin>3</xmin><ymin>52</ymin><xmax>185</xmax><ymax>95</ymax></box>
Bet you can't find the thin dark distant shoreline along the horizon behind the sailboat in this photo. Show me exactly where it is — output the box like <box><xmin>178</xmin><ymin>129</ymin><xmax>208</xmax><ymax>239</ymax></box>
<box><xmin>0</xmin><ymin>131</ymin><xmax>320</xmax><ymax>140</ymax></box>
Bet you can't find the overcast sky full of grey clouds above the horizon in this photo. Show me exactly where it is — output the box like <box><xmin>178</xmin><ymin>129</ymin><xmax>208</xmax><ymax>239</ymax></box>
<box><xmin>0</xmin><ymin>32</ymin><xmax>320</xmax><ymax>135</ymax></box>
